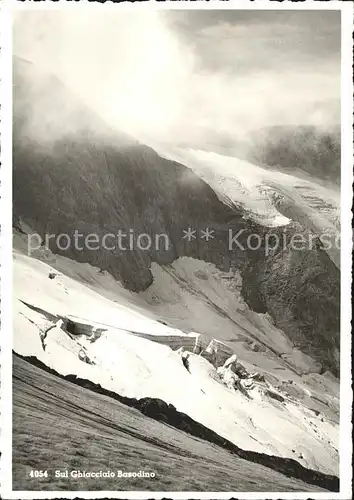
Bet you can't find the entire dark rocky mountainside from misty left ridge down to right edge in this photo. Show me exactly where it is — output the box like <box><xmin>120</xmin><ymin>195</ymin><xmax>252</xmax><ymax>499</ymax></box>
<box><xmin>13</xmin><ymin>59</ymin><xmax>339</xmax><ymax>373</ymax></box>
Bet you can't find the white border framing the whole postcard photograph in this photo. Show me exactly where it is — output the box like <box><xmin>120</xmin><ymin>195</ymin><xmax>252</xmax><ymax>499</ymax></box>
<box><xmin>0</xmin><ymin>0</ymin><xmax>354</xmax><ymax>500</ymax></box>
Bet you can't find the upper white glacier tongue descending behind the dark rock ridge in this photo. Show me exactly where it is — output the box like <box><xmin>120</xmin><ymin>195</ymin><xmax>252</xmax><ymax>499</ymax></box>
<box><xmin>156</xmin><ymin>146</ymin><xmax>340</xmax><ymax>263</ymax></box>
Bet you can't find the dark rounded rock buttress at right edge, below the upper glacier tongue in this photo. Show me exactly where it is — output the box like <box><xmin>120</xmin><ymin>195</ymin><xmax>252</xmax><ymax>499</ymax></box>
<box><xmin>243</xmin><ymin>242</ymin><xmax>340</xmax><ymax>376</ymax></box>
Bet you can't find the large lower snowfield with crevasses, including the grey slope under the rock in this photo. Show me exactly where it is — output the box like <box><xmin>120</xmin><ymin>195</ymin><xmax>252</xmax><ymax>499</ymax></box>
<box><xmin>13</xmin><ymin>249</ymin><xmax>339</xmax><ymax>474</ymax></box>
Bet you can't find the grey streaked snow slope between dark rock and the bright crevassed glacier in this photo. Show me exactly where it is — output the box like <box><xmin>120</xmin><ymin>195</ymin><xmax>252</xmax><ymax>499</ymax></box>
<box><xmin>140</xmin><ymin>257</ymin><xmax>320</xmax><ymax>376</ymax></box>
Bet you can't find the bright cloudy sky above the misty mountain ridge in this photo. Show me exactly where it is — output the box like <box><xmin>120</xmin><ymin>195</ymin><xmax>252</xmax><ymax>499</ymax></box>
<box><xmin>14</xmin><ymin>9</ymin><xmax>340</xmax><ymax>143</ymax></box>
